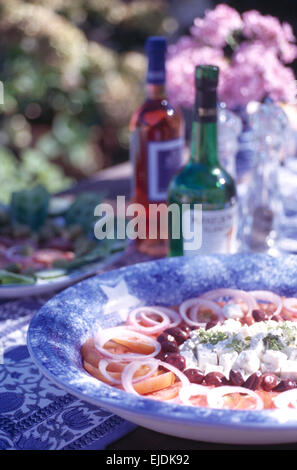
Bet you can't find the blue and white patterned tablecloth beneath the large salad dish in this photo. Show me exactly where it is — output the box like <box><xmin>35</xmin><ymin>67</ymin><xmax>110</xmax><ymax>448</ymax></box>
<box><xmin>0</xmin><ymin>297</ymin><xmax>135</xmax><ymax>450</ymax></box>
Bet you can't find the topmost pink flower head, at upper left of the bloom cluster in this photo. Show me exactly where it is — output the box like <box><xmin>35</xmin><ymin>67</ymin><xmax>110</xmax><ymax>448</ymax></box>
<box><xmin>191</xmin><ymin>3</ymin><xmax>243</xmax><ymax>47</ymax></box>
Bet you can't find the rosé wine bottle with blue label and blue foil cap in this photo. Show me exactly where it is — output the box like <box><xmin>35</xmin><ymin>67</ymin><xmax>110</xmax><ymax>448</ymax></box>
<box><xmin>130</xmin><ymin>36</ymin><xmax>184</xmax><ymax>256</ymax></box>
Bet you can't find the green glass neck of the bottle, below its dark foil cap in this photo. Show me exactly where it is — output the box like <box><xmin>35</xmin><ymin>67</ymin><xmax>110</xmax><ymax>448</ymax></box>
<box><xmin>190</xmin><ymin>88</ymin><xmax>219</xmax><ymax>167</ymax></box>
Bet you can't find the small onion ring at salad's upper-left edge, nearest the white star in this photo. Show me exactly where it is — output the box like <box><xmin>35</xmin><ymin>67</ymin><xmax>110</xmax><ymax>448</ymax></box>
<box><xmin>127</xmin><ymin>307</ymin><xmax>181</xmax><ymax>334</ymax></box>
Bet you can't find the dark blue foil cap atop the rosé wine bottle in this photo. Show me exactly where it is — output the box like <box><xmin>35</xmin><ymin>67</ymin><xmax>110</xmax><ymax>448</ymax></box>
<box><xmin>146</xmin><ymin>36</ymin><xmax>167</xmax><ymax>84</ymax></box>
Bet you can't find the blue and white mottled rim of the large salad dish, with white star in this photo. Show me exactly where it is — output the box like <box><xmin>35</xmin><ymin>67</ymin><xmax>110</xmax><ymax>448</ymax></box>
<box><xmin>28</xmin><ymin>254</ymin><xmax>297</xmax><ymax>444</ymax></box>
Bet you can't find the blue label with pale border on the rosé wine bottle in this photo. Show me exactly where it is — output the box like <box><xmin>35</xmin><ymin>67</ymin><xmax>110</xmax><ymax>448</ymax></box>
<box><xmin>147</xmin><ymin>139</ymin><xmax>184</xmax><ymax>201</ymax></box>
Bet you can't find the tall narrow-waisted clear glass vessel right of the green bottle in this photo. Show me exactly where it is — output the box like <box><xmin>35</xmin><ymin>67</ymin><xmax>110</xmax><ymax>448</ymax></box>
<box><xmin>242</xmin><ymin>102</ymin><xmax>289</xmax><ymax>255</ymax></box>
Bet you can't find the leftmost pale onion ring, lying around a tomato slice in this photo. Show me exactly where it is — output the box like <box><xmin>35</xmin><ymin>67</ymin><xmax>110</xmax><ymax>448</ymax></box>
<box><xmin>94</xmin><ymin>326</ymin><xmax>161</xmax><ymax>362</ymax></box>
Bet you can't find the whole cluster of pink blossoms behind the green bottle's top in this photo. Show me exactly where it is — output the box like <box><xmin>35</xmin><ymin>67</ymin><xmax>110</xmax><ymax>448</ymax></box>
<box><xmin>167</xmin><ymin>4</ymin><xmax>297</xmax><ymax>108</ymax></box>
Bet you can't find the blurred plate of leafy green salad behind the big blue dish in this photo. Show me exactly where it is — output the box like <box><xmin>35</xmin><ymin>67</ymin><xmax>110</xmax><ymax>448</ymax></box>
<box><xmin>0</xmin><ymin>186</ymin><xmax>125</xmax><ymax>291</ymax></box>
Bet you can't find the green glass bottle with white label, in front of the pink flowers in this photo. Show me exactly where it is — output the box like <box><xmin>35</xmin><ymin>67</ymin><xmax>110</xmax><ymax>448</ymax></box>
<box><xmin>168</xmin><ymin>65</ymin><xmax>237</xmax><ymax>256</ymax></box>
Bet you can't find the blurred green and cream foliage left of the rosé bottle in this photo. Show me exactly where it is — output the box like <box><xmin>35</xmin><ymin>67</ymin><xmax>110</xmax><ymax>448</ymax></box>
<box><xmin>0</xmin><ymin>0</ymin><xmax>168</xmax><ymax>202</ymax></box>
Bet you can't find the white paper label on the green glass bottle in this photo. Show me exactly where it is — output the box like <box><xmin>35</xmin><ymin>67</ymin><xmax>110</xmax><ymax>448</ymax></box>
<box><xmin>182</xmin><ymin>204</ymin><xmax>238</xmax><ymax>255</ymax></box>
